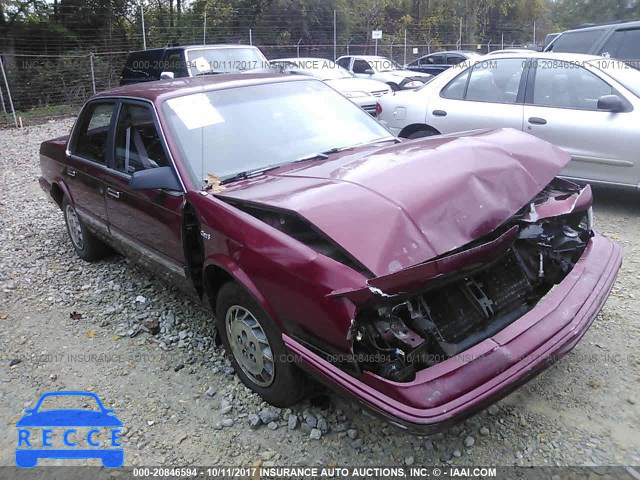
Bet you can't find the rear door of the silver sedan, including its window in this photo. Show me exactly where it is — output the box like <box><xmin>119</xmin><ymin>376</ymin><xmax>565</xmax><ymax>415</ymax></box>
<box><xmin>425</xmin><ymin>58</ymin><xmax>526</xmax><ymax>133</ymax></box>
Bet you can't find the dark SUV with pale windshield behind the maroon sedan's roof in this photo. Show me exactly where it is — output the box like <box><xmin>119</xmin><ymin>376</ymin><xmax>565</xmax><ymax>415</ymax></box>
<box><xmin>120</xmin><ymin>45</ymin><xmax>269</xmax><ymax>85</ymax></box>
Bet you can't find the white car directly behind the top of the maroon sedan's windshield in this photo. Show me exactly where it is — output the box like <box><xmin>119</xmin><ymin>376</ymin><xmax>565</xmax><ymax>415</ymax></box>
<box><xmin>269</xmin><ymin>57</ymin><xmax>391</xmax><ymax>115</ymax></box>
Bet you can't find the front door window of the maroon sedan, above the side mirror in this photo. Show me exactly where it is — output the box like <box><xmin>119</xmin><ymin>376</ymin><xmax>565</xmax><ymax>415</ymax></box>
<box><xmin>113</xmin><ymin>103</ymin><xmax>169</xmax><ymax>175</ymax></box>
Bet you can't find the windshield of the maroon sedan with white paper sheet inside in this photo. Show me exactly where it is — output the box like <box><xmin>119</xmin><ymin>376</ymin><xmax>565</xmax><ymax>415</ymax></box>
<box><xmin>162</xmin><ymin>80</ymin><xmax>393</xmax><ymax>185</ymax></box>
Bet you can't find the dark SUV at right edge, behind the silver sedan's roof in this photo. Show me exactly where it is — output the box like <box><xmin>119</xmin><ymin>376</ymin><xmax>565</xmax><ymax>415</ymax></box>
<box><xmin>545</xmin><ymin>20</ymin><xmax>640</xmax><ymax>68</ymax></box>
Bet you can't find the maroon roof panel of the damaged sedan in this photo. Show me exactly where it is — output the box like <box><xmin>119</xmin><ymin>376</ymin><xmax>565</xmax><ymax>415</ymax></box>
<box><xmin>91</xmin><ymin>73</ymin><xmax>318</xmax><ymax>102</ymax></box>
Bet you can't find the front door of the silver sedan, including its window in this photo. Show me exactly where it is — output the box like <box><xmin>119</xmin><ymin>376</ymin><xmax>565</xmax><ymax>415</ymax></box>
<box><xmin>524</xmin><ymin>59</ymin><xmax>640</xmax><ymax>185</ymax></box>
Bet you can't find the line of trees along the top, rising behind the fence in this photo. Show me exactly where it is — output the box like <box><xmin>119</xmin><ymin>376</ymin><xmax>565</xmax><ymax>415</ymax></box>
<box><xmin>0</xmin><ymin>0</ymin><xmax>640</xmax><ymax>54</ymax></box>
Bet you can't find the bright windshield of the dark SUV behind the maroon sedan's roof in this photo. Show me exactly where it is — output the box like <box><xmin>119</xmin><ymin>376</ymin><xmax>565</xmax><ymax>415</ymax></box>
<box><xmin>187</xmin><ymin>47</ymin><xmax>269</xmax><ymax>77</ymax></box>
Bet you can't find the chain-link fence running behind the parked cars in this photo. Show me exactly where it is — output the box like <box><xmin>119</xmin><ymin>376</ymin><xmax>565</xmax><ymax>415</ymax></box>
<box><xmin>0</xmin><ymin>43</ymin><xmax>514</xmax><ymax>127</ymax></box>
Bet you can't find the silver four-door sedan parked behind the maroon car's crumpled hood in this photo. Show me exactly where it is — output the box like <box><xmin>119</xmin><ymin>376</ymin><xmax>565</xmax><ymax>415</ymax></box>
<box><xmin>378</xmin><ymin>52</ymin><xmax>640</xmax><ymax>188</ymax></box>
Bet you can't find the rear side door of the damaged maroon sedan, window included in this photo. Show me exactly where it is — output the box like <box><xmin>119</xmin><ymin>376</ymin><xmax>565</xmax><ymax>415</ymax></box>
<box><xmin>63</xmin><ymin>100</ymin><xmax>116</xmax><ymax>233</ymax></box>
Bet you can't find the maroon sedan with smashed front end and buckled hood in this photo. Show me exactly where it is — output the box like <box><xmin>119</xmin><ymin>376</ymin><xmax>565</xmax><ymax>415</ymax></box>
<box><xmin>40</xmin><ymin>75</ymin><xmax>621</xmax><ymax>432</ymax></box>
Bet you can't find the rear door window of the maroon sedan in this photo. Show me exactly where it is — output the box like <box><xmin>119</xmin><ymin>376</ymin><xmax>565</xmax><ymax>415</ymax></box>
<box><xmin>72</xmin><ymin>102</ymin><xmax>115</xmax><ymax>165</ymax></box>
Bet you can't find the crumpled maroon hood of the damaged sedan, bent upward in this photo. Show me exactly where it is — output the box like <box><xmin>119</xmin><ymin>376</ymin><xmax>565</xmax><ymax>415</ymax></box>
<box><xmin>221</xmin><ymin>129</ymin><xmax>570</xmax><ymax>276</ymax></box>
